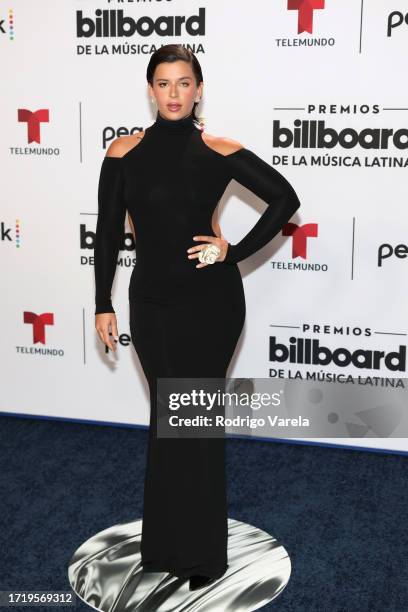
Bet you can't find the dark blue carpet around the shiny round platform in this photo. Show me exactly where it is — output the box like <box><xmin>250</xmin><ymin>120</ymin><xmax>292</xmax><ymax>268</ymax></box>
<box><xmin>0</xmin><ymin>416</ymin><xmax>408</xmax><ymax>612</ymax></box>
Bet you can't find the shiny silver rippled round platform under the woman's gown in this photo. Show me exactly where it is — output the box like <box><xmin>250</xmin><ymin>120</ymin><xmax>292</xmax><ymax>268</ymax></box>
<box><xmin>68</xmin><ymin>519</ymin><xmax>291</xmax><ymax>612</ymax></box>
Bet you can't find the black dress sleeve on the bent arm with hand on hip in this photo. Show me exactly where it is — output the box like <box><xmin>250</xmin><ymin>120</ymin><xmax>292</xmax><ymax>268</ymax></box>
<box><xmin>222</xmin><ymin>148</ymin><xmax>300</xmax><ymax>264</ymax></box>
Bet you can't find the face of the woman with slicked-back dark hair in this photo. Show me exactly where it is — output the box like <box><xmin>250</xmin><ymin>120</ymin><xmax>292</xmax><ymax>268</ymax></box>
<box><xmin>148</xmin><ymin>60</ymin><xmax>203</xmax><ymax>119</ymax></box>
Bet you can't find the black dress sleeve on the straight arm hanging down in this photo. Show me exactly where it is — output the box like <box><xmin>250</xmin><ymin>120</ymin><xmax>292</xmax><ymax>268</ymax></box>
<box><xmin>94</xmin><ymin>157</ymin><xmax>126</xmax><ymax>314</ymax></box>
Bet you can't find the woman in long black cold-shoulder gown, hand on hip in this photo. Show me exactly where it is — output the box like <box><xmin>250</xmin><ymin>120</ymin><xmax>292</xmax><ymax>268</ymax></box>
<box><xmin>94</xmin><ymin>45</ymin><xmax>300</xmax><ymax>589</ymax></box>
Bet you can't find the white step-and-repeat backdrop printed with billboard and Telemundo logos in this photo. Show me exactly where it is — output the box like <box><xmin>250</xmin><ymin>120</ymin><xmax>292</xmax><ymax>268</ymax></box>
<box><xmin>0</xmin><ymin>0</ymin><xmax>408</xmax><ymax>451</ymax></box>
